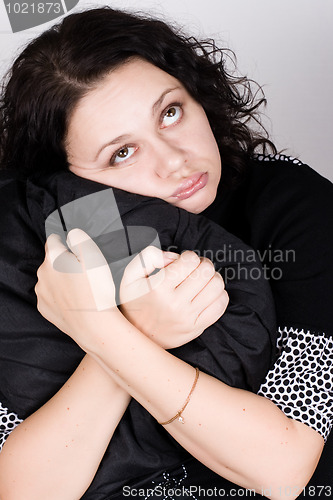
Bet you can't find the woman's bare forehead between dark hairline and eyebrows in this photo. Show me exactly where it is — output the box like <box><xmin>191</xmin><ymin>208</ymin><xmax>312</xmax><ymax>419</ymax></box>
<box><xmin>66</xmin><ymin>59</ymin><xmax>183</xmax><ymax>158</ymax></box>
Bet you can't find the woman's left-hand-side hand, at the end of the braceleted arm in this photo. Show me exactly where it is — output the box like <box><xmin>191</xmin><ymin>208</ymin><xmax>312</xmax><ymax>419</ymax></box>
<box><xmin>35</xmin><ymin>229</ymin><xmax>120</xmax><ymax>346</ymax></box>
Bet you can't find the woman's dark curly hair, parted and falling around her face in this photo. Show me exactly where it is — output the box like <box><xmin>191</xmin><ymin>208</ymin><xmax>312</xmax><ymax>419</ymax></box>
<box><xmin>0</xmin><ymin>7</ymin><xmax>276</xmax><ymax>185</ymax></box>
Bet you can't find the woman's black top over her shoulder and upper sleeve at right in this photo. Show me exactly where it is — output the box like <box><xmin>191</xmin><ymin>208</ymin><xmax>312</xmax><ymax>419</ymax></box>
<box><xmin>204</xmin><ymin>157</ymin><xmax>333</xmax><ymax>492</ymax></box>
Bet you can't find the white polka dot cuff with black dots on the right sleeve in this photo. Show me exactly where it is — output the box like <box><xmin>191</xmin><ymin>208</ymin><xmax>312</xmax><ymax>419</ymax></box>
<box><xmin>258</xmin><ymin>327</ymin><xmax>333</xmax><ymax>441</ymax></box>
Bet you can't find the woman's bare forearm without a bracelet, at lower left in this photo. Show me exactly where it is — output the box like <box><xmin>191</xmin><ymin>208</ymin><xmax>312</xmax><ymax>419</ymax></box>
<box><xmin>0</xmin><ymin>356</ymin><xmax>130</xmax><ymax>500</ymax></box>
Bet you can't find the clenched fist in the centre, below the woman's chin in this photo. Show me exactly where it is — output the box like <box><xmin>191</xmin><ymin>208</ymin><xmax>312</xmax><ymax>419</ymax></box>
<box><xmin>120</xmin><ymin>247</ymin><xmax>229</xmax><ymax>349</ymax></box>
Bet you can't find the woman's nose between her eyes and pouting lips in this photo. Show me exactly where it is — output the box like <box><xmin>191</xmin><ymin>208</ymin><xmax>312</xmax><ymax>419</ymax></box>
<box><xmin>155</xmin><ymin>138</ymin><xmax>188</xmax><ymax>179</ymax></box>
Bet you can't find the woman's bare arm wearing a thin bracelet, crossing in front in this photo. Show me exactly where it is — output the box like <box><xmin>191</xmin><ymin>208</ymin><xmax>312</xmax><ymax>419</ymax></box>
<box><xmin>35</xmin><ymin>232</ymin><xmax>323</xmax><ymax>498</ymax></box>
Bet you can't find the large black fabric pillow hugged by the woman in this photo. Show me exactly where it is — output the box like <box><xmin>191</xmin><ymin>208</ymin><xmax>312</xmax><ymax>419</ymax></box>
<box><xmin>0</xmin><ymin>167</ymin><xmax>276</xmax><ymax>500</ymax></box>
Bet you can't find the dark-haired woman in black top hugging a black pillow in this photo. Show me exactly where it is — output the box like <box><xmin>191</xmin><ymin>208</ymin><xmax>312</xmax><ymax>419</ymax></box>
<box><xmin>0</xmin><ymin>4</ymin><xmax>332</xmax><ymax>498</ymax></box>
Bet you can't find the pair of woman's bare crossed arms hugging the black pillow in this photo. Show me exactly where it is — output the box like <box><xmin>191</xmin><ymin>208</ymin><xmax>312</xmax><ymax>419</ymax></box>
<box><xmin>0</xmin><ymin>233</ymin><xmax>323</xmax><ymax>500</ymax></box>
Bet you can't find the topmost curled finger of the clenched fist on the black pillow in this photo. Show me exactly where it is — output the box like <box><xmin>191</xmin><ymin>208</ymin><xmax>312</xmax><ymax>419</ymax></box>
<box><xmin>123</xmin><ymin>246</ymin><xmax>179</xmax><ymax>285</ymax></box>
